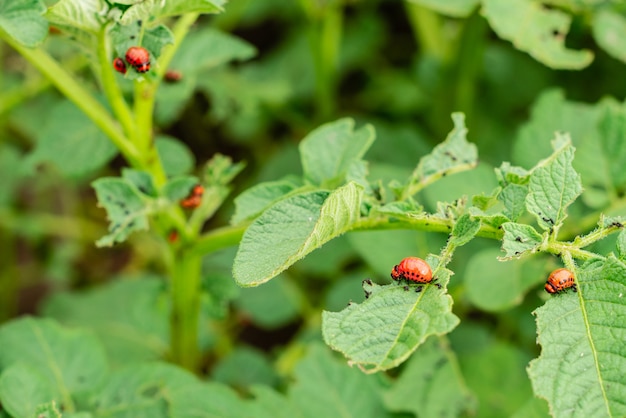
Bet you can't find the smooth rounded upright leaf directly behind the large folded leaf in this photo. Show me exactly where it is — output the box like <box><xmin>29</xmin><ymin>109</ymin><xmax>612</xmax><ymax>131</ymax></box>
<box><xmin>299</xmin><ymin>118</ymin><xmax>375</xmax><ymax>185</ymax></box>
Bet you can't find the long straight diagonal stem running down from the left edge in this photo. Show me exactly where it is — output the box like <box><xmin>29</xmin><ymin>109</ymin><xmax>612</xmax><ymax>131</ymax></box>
<box><xmin>0</xmin><ymin>31</ymin><xmax>141</xmax><ymax>166</ymax></box>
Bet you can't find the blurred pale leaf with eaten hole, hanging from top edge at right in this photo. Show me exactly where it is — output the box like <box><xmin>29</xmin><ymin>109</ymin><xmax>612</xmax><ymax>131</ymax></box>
<box><xmin>482</xmin><ymin>0</ymin><xmax>593</xmax><ymax>70</ymax></box>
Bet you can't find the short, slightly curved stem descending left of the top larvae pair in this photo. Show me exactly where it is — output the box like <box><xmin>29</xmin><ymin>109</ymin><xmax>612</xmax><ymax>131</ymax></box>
<box><xmin>98</xmin><ymin>26</ymin><xmax>135</xmax><ymax>138</ymax></box>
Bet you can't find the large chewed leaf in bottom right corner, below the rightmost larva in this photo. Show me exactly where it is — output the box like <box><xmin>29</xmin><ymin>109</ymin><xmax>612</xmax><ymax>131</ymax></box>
<box><xmin>528</xmin><ymin>256</ymin><xmax>626</xmax><ymax>417</ymax></box>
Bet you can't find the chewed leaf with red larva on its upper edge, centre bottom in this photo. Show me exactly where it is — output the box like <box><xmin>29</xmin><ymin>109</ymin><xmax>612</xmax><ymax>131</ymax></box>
<box><xmin>322</xmin><ymin>256</ymin><xmax>459</xmax><ymax>373</ymax></box>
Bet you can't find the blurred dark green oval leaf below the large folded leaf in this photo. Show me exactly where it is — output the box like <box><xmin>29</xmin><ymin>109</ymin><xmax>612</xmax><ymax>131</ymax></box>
<box><xmin>235</xmin><ymin>280</ymin><xmax>304</xmax><ymax>329</ymax></box>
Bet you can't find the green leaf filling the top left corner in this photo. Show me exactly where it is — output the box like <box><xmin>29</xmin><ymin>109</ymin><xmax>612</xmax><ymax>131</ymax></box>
<box><xmin>0</xmin><ymin>0</ymin><xmax>48</xmax><ymax>48</ymax></box>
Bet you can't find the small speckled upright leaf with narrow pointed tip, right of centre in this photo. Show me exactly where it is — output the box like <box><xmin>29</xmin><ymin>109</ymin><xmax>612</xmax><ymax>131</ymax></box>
<box><xmin>404</xmin><ymin>113</ymin><xmax>478</xmax><ymax>197</ymax></box>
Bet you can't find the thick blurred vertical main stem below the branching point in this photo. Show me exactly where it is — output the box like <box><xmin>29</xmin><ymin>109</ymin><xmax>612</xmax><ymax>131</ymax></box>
<box><xmin>170</xmin><ymin>249</ymin><xmax>202</xmax><ymax>372</ymax></box>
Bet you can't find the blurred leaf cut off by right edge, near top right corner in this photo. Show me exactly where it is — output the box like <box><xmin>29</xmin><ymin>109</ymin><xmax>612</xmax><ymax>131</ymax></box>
<box><xmin>591</xmin><ymin>8</ymin><xmax>626</xmax><ymax>62</ymax></box>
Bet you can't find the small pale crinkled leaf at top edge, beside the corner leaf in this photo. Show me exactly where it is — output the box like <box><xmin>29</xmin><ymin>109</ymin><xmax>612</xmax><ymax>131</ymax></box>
<box><xmin>46</xmin><ymin>0</ymin><xmax>107</xmax><ymax>35</ymax></box>
